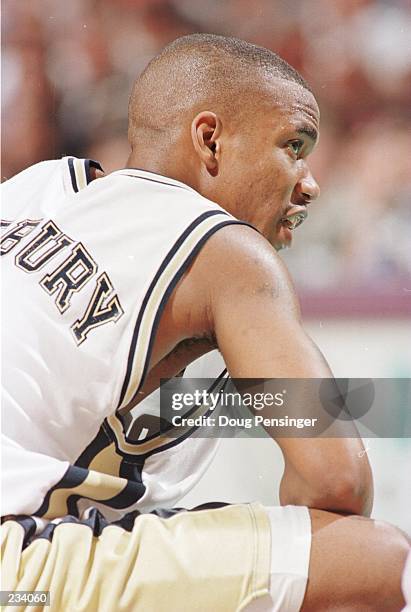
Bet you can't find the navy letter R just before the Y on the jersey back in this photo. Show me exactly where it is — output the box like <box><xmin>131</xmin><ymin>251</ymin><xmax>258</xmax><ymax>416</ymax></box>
<box><xmin>40</xmin><ymin>243</ymin><xmax>97</xmax><ymax>314</ymax></box>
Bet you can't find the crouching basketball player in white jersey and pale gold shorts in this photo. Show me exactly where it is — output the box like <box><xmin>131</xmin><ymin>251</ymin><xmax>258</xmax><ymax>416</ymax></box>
<box><xmin>1</xmin><ymin>35</ymin><xmax>409</xmax><ymax>612</ymax></box>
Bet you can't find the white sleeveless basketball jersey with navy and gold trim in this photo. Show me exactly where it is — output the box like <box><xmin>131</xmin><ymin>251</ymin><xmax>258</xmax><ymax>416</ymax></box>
<box><xmin>1</xmin><ymin>158</ymin><xmax>245</xmax><ymax>519</ymax></box>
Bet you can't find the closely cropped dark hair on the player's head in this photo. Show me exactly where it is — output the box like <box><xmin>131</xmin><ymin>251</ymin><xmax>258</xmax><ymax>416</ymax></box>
<box><xmin>129</xmin><ymin>34</ymin><xmax>310</xmax><ymax>146</ymax></box>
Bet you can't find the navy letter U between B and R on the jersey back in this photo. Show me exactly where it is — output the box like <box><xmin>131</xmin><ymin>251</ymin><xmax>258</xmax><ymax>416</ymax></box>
<box><xmin>15</xmin><ymin>221</ymin><xmax>73</xmax><ymax>272</ymax></box>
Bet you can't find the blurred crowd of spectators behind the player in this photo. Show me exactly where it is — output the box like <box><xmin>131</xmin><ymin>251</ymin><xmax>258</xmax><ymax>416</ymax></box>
<box><xmin>2</xmin><ymin>0</ymin><xmax>411</xmax><ymax>302</ymax></box>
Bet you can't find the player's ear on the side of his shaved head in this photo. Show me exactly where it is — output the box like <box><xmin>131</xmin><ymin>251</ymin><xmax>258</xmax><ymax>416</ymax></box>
<box><xmin>191</xmin><ymin>111</ymin><xmax>222</xmax><ymax>176</ymax></box>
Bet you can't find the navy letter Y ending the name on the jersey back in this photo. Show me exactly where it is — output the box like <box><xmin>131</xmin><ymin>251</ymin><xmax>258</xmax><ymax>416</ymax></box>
<box><xmin>71</xmin><ymin>272</ymin><xmax>124</xmax><ymax>345</ymax></box>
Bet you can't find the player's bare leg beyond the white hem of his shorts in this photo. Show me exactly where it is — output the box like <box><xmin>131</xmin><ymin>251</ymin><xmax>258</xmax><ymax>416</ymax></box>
<box><xmin>303</xmin><ymin>510</ymin><xmax>410</xmax><ymax>612</ymax></box>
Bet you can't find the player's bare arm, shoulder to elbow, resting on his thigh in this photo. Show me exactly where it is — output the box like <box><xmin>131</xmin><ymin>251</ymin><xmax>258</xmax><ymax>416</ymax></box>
<box><xmin>192</xmin><ymin>226</ymin><xmax>372</xmax><ymax>513</ymax></box>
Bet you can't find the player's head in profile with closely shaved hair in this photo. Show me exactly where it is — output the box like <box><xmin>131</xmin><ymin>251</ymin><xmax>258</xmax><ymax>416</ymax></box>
<box><xmin>127</xmin><ymin>34</ymin><xmax>320</xmax><ymax>248</ymax></box>
